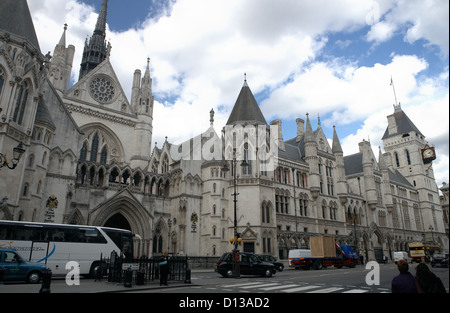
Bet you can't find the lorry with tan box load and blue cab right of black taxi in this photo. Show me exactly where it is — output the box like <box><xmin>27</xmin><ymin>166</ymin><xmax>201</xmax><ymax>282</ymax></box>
<box><xmin>289</xmin><ymin>236</ymin><xmax>359</xmax><ymax>269</ymax></box>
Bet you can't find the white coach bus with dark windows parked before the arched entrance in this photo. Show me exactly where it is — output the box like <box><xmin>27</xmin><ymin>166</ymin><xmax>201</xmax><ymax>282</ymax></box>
<box><xmin>0</xmin><ymin>221</ymin><xmax>133</xmax><ymax>276</ymax></box>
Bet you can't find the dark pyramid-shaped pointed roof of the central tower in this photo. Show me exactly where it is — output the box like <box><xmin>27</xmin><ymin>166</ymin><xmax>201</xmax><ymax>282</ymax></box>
<box><xmin>227</xmin><ymin>80</ymin><xmax>267</xmax><ymax>125</ymax></box>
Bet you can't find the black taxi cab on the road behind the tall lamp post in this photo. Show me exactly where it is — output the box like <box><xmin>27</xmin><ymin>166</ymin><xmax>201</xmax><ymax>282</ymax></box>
<box><xmin>216</xmin><ymin>252</ymin><xmax>277</xmax><ymax>277</ymax></box>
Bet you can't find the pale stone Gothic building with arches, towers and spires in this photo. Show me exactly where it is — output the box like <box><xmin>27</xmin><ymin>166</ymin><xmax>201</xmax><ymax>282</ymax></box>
<box><xmin>0</xmin><ymin>0</ymin><xmax>448</xmax><ymax>260</ymax></box>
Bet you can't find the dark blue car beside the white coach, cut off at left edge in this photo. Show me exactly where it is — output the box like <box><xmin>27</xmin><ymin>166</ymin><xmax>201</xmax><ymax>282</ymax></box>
<box><xmin>0</xmin><ymin>249</ymin><xmax>46</xmax><ymax>284</ymax></box>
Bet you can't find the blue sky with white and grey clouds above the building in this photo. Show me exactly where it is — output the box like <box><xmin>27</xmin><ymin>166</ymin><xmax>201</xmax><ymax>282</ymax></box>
<box><xmin>28</xmin><ymin>0</ymin><xmax>449</xmax><ymax>186</ymax></box>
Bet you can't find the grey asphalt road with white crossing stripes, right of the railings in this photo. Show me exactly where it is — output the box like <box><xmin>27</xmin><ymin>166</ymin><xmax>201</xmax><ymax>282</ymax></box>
<box><xmin>129</xmin><ymin>264</ymin><xmax>449</xmax><ymax>294</ymax></box>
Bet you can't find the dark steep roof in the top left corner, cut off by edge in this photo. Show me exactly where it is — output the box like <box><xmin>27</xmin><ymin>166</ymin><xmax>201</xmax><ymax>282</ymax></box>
<box><xmin>0</xmin><ymin>0</ymin><xmax>41</xmax><ymax>52</ymax></box>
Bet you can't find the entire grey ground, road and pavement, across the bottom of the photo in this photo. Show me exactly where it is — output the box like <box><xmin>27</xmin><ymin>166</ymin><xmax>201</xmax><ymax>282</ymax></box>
<box><xmin>0</xmin><ymin>264</ymin><xmax>449</xmax><ymax>294</ymax></box>
